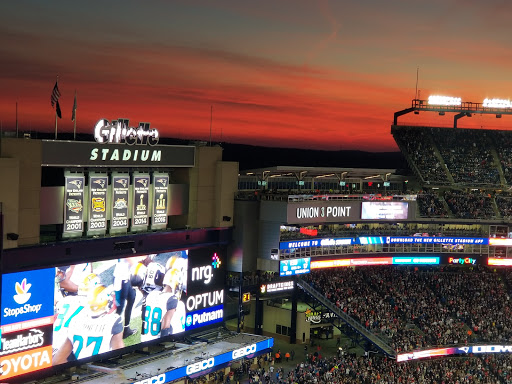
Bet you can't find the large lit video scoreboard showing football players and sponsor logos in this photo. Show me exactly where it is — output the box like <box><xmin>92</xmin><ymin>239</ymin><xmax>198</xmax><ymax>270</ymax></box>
<box><xmin>0</xmin><ymin>249</ymin><xmax>224</xmax><ymax>381</ymax></box>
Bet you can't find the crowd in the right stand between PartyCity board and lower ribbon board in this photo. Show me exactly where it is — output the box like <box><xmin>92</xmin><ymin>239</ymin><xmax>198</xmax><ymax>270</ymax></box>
<box><xmin>306</xmin><ymin>266</ymin><xmax>512</xmax><ymax>352</ymax></box>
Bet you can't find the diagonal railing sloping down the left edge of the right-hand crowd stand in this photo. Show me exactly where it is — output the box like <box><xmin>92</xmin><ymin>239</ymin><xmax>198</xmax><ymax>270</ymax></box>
<box><xmin>297</xmin><ymin>277</ymin><xmax>396</xmax><ymax>358</ymax></box>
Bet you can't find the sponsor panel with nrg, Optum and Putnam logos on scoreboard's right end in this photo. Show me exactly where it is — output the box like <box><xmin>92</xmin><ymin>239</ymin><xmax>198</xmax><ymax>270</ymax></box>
<box><xmin>185</xmin><ymin>249</ymin><xmax>224</xmax><ymax>330</ymax></box>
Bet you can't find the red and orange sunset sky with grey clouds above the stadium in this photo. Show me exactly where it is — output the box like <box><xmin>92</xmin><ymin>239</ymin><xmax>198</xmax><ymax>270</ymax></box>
<box><xmin>0</xmin><ymin>0</ymin><xmax>512</xmax><ymax>152</ymax></box>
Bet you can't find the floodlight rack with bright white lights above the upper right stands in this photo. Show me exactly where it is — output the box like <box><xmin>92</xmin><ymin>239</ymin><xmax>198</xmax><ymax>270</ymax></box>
<box><xmin>393</xmin><ymin>98</ymin><xmax>512</xmax><ymax>128</ymax></box>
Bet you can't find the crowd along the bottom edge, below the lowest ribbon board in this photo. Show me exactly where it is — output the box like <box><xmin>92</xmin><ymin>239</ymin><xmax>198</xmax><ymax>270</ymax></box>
<box><xmin>242</xmin><ymin>354</ymin><xmax>512</xmax><ymax>384</ymax></box>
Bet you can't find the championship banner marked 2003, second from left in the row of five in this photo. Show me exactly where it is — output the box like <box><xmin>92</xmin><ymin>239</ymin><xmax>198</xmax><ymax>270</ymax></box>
<box><xmin>88</xmin><ymin>175</ymin><xmax>108</xmax><ymax>234</ymax></box>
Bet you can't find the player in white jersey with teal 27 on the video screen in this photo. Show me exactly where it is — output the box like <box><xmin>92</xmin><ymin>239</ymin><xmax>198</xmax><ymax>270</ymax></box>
<box><xmin>53</xmin><ymin>284</ymin><xmax>124</xmax><ymax>365</ymax></box>
